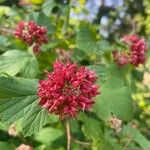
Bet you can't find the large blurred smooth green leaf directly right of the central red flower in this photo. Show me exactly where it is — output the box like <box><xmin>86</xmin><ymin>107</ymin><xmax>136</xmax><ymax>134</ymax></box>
<box><xmin>94</xmin><ymin>66</ymin><xmax>133</xmax><ymax>121</ymax></box>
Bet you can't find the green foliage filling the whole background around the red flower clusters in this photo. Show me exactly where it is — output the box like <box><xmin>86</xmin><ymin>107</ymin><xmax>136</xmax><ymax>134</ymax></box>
<box><xmin>0</xmin><ymin>0</ymin><xmax>150</xmax><ymax>150</ymax></box>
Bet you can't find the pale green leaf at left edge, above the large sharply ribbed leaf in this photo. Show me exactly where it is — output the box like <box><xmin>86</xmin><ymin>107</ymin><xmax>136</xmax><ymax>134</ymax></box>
<box><xmin>0</xmin><ymin>50</ymin><xmax>38</xmax><ymax>78</ymax></box>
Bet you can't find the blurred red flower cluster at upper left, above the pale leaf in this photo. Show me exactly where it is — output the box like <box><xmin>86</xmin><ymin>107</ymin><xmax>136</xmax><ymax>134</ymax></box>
<box><xmin>14</xmin><ymin>21</ymin><xmax>48</xmax><ymax>53</ymax></box>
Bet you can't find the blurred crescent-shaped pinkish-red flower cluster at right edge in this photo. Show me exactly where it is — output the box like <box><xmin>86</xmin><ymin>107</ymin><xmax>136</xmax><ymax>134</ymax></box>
<box><xmin>113</xmin><ymin>35</ymin><xmax>147</xmax><ymax>66</ymax></box>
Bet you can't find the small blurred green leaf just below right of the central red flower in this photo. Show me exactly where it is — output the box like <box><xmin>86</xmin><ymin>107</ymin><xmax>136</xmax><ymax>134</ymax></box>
<box><xmin>79</xmin><ymin>113</ymin><xmax>103</xmax><ymax>139</ymax></box>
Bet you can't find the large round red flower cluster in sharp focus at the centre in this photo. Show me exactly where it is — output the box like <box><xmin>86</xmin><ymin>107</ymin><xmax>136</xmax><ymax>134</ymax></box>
<box><xmin>38</xmin><ymin>61</ymin><xmax>99</xmax><ymax>120</ymax></box>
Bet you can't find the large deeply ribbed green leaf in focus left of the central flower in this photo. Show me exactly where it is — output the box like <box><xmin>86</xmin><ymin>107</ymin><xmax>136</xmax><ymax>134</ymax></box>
<box><xmin>0</xmin><ymin>76</ymin><xmax>48</xmax><ymax>136</ymax></box>
